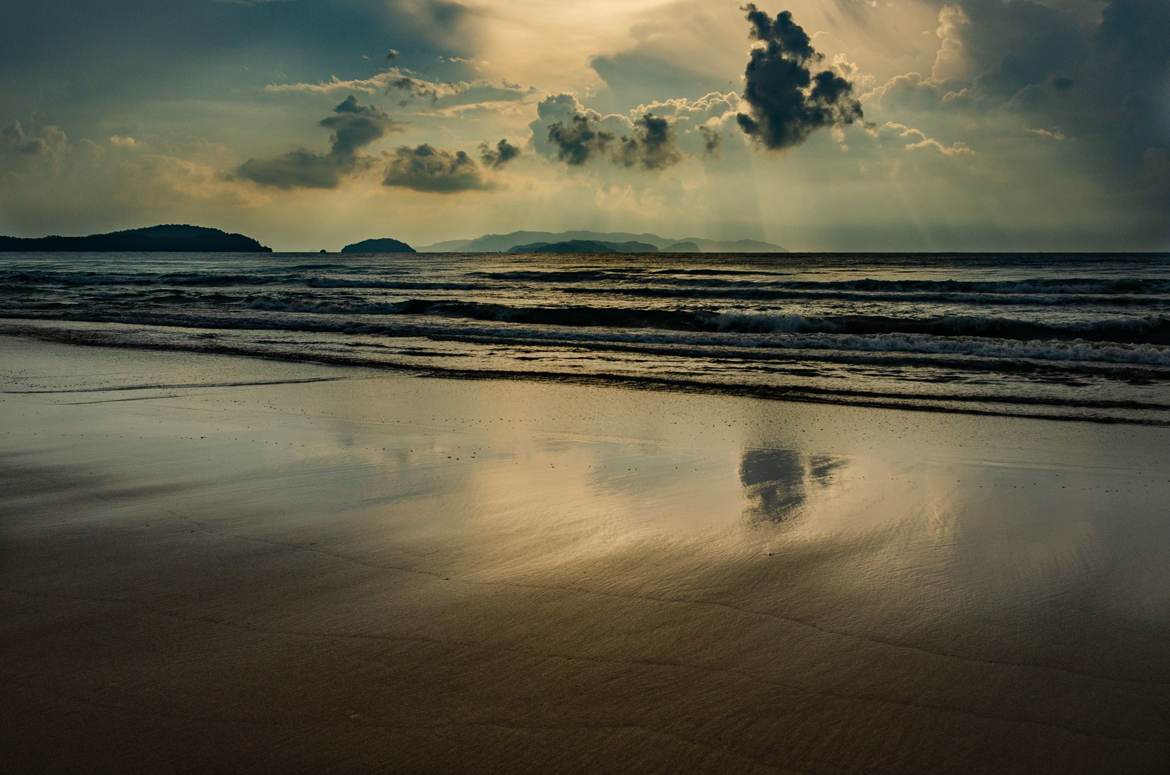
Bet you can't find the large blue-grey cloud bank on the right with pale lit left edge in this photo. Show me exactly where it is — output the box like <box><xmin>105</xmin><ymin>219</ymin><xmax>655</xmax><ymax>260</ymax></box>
<box><xmin>865</xmin><ymin>0</ymin><xmax>1170</xmax><ymax>230</ymax></box>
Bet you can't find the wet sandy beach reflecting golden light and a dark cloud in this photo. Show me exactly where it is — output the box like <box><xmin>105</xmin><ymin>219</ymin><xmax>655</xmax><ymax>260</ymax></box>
<box><xmin>0</xmin><ymin>338</ymin><xmax>1170</xmax><ymax>773</ymax></box>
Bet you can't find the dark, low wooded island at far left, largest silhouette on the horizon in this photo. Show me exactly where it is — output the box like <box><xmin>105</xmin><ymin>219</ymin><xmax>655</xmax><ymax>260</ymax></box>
<box><xmin>0</xmin><ymin>224</ymin><xmax>273</xmax><ymax>253</ymax></box>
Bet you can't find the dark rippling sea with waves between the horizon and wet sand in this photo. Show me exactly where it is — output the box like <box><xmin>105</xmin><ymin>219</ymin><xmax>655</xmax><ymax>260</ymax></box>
<box><xmin>0</xmin><ymin>254</ymin><xmax>1170</xmax><ymax>425</ymax></box>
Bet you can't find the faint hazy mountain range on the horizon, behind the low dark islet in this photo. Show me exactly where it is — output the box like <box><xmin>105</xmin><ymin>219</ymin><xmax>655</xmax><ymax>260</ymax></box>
<box><xmin>419</xmin><ymin>231</ymin><xmax>786</xmax><ymax>253</ymax></box>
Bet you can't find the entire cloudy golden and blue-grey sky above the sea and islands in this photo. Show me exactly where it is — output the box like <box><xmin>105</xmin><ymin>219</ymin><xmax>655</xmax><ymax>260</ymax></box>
<box><xmin>0</xmin><ymin>0</ymin><xmax>1170</xmax><ymax>251</ymax></box>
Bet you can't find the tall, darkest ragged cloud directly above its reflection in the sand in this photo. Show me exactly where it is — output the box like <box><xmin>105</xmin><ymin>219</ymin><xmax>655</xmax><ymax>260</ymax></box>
<box><xmin>736</xmin><ymin>4</ymin><xmax>862</xmax><ymax>150</ymax></box>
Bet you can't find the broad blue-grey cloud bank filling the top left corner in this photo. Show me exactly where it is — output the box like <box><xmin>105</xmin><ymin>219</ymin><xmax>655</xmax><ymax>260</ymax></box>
<box><xmin>0</xmin><ymin>0</ymin><xmax>477</xmax><ymax>115</ymax></box>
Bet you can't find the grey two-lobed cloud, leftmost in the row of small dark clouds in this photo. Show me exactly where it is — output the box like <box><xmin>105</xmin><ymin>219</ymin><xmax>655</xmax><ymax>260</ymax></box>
<box><xmin>236</xmin><ymin>95</ymin><xmax>400</xmax><ymax>188</ymax></box>
